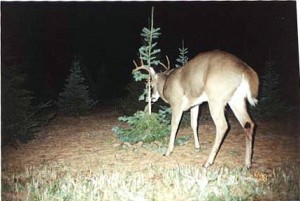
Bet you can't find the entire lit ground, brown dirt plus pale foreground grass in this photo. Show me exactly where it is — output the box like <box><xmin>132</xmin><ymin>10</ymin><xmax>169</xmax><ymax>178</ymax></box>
<box><xmin>1</xmin><ymin>106</ymin><xmax>300</xmax><ymax>201</ymax></box>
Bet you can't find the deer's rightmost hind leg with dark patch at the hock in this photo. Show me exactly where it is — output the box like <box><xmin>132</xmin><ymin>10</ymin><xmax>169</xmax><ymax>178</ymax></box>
<box><xmin>229</xmin><ymin>98</ymin><xmax>254</xmax><ymax>169</ymax></box>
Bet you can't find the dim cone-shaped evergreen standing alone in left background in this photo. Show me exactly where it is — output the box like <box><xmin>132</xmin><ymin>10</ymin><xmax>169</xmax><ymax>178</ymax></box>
<box><xmin>58</xmin><ymin>59</ymin><xmax>96</xmax><ymax>116</ymax></box>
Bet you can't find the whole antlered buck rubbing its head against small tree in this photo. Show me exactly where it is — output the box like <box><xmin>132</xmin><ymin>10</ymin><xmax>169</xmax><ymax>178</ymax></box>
<box><xmin>134</xmin><ymin>50</ymin><xmax>259</xmax><ymax>168</ymax></box>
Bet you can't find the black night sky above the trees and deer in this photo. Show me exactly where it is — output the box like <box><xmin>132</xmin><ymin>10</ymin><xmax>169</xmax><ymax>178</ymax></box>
<box><xmin>1</xmin><ymin>2</ymin><xmax>299</xmax><ymax>101</ymax></box>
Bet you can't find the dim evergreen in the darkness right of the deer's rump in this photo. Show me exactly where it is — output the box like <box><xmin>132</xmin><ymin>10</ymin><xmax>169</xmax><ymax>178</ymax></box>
<box><xmin>253</xmin><ymin>59</ymin><xmax>289</xmax><ymax>119</ymax></box>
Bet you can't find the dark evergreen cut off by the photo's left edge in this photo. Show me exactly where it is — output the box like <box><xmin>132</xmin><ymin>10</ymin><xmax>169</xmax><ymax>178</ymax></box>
<box><xmin>1</xmin><ymin>65</ymin><xmax>55</xmax><ymax>144</ymax></box>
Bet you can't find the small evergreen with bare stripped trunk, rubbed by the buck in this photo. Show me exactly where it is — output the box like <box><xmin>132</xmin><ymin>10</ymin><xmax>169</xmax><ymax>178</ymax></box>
<box><xmin>112</xmin><ymin>8</ymin><xmax>170</xmax><ymax>143</ymax></box>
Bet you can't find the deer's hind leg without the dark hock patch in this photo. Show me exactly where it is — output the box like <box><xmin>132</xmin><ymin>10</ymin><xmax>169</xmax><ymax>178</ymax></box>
<box><xmin>204</xmin><ymin>101</ymin><xmax>228</xmax><ymax>167</ymax></box>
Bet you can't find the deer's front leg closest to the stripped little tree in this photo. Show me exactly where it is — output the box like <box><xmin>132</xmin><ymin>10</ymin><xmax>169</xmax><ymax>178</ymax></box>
<box><xmin>164</xmin><ymin>108</ymin><xmax>183</xmax><ymax>156</ymax></box>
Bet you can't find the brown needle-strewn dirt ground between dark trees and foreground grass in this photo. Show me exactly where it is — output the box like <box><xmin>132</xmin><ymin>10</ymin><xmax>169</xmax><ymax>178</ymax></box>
<box><xmin>2</xmin><ymin>108</ymin><xmax>300</xmax><ymax>172</ymax></box>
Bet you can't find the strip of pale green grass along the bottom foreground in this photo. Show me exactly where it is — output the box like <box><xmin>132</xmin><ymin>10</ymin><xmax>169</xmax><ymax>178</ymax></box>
<box><xmin>2</xmin><ymin>163</ymin><xmax>300</xmax><ymax>201</ymax></box>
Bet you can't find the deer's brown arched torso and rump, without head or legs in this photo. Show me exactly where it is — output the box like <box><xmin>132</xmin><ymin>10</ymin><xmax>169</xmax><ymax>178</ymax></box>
<box><xmin>163</xmin><ymin>50</ymin><xmax>258</xmax><ymax>104</ymax></box>
